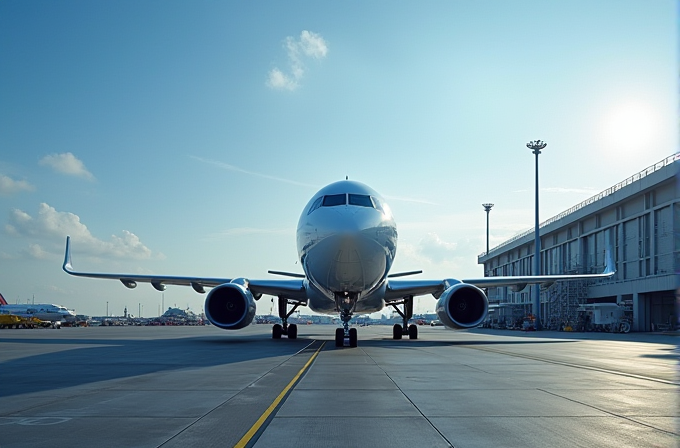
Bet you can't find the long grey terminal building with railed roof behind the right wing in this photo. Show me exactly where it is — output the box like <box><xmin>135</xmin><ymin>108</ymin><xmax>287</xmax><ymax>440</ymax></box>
<box><xmin>478</xmin><ymin>154</ymin><xmax>680</xmax><ymax>331</ymax></box>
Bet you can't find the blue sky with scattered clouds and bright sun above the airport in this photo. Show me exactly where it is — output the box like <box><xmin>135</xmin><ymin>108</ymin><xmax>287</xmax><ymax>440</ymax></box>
<box><xmin>0</xmin><ymin>0</ymin><xmax>678</xmax><ymax>316</ymax></box>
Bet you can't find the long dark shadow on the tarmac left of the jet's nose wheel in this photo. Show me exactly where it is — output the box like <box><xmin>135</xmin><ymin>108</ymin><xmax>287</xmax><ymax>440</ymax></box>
<box><xmin>0</xmin><ymin>336</ymin><xmax>311</xmax><ymax>398</ymax></box>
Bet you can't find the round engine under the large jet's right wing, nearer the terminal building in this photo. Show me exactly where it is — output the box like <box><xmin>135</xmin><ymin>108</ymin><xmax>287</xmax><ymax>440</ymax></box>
<box><xmin>437</xmin><ymin>283</ymin><xmax>489</xmax><ymax>329</ymax></box>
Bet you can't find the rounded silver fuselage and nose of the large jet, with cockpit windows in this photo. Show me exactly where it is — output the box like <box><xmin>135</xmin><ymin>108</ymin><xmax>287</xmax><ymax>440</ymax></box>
<box><xmin>297</xmin><ymin>181</ymin><xmax>397</xmax><ymax>314</ymax></box>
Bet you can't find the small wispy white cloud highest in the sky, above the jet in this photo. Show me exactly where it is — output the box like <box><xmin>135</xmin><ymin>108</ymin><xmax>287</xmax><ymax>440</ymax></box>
<box><xmin>267</xmin><ymin>30</ymin><xmax>328</xmax><ymax>91</ymax></box>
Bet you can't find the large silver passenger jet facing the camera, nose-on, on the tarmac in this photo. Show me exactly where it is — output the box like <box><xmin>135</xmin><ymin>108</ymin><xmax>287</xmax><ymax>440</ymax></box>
<box><xmin>62</xmin><ymin>180</ymin><xmax>615</xmax><ymax>347</ymax></box>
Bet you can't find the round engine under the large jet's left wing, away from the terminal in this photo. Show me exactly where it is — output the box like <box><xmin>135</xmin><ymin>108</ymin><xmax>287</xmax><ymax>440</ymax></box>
<box><xmin>205</xmin><ymin>283</ymin><xmax>256</xmax><ymax>330</ymax></box>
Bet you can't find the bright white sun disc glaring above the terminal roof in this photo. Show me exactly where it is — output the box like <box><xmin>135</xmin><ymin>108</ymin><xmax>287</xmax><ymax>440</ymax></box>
<box><xmin>603</xmin><ymin>102</ymin><xmax>659</xmax><ymax>151</ymax></box>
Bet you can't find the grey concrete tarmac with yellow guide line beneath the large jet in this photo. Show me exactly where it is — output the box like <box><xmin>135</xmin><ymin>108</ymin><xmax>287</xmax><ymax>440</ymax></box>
<box><xmin>0</xmin><ymin>325</ymin><xmax>680</xmax><ymax>448</ymax></box>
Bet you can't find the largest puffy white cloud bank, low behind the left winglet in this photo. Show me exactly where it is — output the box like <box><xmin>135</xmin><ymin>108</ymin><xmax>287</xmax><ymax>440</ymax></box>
<box><xmin>5</xmin><ymin>203</ymin><xmax>152</xmax><ymax>259</ymax></box>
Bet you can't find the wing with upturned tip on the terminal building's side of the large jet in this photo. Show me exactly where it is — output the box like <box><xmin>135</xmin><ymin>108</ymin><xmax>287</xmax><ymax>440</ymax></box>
<box><xmin>385</xmin><ymin>249</ymin><xmax>616</xmax><ymax>303</ymax></box>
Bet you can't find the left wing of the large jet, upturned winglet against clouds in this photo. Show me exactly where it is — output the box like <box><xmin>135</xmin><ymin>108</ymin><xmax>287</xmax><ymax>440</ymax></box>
<box><xmin>62</xmin><ymin>236</ymin><xmax>307</xmax><ymax>302</ymax></box>
